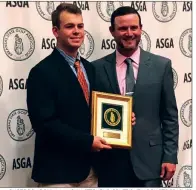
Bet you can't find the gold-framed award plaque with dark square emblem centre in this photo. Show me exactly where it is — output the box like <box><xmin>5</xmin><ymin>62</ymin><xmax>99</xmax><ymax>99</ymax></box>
<box><xmin>91</xmin><ymin>91</ymin><xmax>133</xmax><ymax>148</ymax></box>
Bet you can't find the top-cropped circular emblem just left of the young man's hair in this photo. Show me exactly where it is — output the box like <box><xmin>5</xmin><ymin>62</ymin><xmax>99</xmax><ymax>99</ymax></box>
<box><xmin>36</xmin><ymin>1</ymin><xmax>61</xmax><ymax>21</ymax></box>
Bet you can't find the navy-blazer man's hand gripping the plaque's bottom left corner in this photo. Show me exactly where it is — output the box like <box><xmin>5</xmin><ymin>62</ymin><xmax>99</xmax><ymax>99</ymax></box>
<box><xmin>92</xmin><ymin>137</ymin><xmax>112</xmax><ymax>152</ymax></box>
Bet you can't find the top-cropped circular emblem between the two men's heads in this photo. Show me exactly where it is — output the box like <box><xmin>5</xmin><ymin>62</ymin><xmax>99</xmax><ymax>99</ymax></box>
<box><xmin>96</xmin><ymin>1</ymin><xmax>123</xmax><ymax>22</ymax></box>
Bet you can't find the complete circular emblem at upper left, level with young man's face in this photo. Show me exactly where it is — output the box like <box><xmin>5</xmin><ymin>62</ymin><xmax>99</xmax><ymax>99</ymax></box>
<box><xmin>3</xmin><ymin>27</ymin><xmax>35</xmax><ymax>61</ymax></box>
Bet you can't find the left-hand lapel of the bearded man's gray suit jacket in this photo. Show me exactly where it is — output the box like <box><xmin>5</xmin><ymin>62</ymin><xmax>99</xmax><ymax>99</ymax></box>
<box><xmin>104</xmin><ymin>52</ymin><xmax>120</xmax><ymax>94</ymax></box>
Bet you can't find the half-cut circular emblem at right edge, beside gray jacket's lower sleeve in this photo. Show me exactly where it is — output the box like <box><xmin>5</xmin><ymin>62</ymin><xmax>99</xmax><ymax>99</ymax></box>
<box><xmin>180</xmin><ymin>99</ymin><xmax>192</xmax><ymax>127</ymax></box>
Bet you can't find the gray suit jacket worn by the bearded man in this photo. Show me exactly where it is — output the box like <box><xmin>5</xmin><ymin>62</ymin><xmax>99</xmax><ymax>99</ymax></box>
<box><xmin>93</xmin><ymin>49</ymin><xmax>179</xmax><ymax>180</ymax></box>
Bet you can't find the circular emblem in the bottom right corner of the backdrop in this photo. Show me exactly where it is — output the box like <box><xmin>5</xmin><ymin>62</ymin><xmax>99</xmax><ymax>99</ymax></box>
<box><xmin>176</xmin><ymin>166</ymin><xmax>192</xmax><ymax>188</ymax></box>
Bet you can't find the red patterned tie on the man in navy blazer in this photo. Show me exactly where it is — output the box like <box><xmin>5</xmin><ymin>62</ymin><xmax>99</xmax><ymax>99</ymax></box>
<box><xmin>74</xmin><ymin>60</ymin><xmax>89</xmax><ymax>104</ymax></box>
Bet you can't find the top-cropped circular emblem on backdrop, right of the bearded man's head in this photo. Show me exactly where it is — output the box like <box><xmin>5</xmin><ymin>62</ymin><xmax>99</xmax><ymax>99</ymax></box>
<box><xmin>152</xmin><ymin>1</ymin><xmax>177</xmax><ymax>22</ymax></box>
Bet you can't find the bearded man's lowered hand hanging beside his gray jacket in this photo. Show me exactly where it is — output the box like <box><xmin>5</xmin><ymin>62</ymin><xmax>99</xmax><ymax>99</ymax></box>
<box><xmin>160</xmin><ymin>163</ymin><xmax>176</xmax><ymax>180</ymax></box>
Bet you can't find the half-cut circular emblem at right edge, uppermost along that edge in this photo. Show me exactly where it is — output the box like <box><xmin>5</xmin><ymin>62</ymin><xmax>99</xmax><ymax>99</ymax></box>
<box><xmin>179</xmin><ymin>28</ymin><xmax>192</xmax><ymax>57</ymax></box>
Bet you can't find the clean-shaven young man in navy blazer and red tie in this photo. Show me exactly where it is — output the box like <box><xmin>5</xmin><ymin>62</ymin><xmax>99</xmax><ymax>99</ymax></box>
<box><xmin>27</xmin><ymin>3</ymin><xmax>111</xmax><ymax>187</ymax></box>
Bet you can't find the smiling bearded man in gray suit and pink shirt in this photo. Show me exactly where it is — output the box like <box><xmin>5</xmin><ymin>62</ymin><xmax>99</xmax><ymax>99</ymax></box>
<box><xmin>93</xmin><ymin>6</ymin><xmax>179</xmax><ymax>187</ymax></box>
